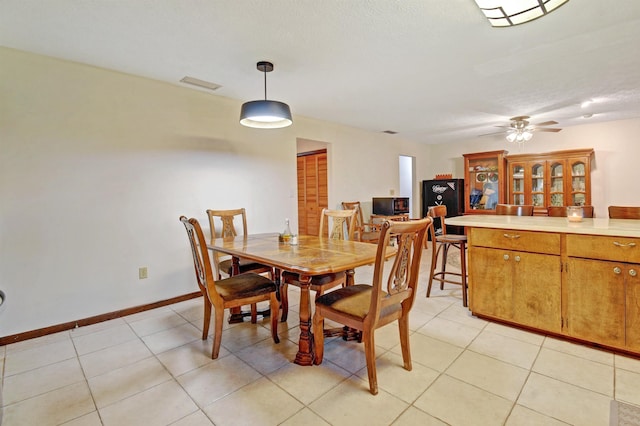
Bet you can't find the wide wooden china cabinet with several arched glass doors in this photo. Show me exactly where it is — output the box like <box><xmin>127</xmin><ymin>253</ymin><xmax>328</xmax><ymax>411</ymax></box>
<box><xmin>506</xmin><ymin>149</ymin><xmax>593</xmax><ymax>216</ymax></box>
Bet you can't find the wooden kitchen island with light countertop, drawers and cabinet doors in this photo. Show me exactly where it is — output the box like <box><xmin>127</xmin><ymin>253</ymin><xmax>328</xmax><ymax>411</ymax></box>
<box><xmin>447</xmin><ymin>215</ymin><xmax>640</xmax><ymax>356</ymax></box>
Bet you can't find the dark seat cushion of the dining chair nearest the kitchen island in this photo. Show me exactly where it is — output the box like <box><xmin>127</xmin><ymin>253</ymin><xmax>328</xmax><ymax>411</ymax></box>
<box><xmin>316</xmin><ymin>284</ymin><xmax>402</xmax><ymax>319</ymax></box>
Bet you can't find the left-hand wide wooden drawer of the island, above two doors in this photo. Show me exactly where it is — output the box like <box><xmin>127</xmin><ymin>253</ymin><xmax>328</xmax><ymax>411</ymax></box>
<box><xmin>469</xmin><ymin>228</ymin><xmax>560</xmax><ymax>254</ymax></box>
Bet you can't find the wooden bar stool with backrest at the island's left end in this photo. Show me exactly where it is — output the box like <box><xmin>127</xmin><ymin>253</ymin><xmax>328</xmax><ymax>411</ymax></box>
<box><xmin>427</xmin><ymin>205</ymin><xmax>468</xmax><ymax>306</ymax></box>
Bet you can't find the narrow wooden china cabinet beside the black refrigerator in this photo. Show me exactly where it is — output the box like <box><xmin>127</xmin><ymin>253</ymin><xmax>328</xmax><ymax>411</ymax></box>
<box><xmin>463</xmin><ymin>151</ymin><xmax>507</xmax><ymax>214</ymax></box>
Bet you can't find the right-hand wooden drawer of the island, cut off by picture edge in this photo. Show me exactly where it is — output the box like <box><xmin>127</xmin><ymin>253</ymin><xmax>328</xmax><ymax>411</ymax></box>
<box><xmin>567</xmin><ymin>234</ymin><xmax>640</xmax><ymax>263</ymax></box>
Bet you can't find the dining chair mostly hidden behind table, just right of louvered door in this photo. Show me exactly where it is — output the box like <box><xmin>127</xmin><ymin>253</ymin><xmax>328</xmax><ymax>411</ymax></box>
<box><xmin>280</xmin><ymin>209</ymin><xmax>357</xmax><ymax>322</ymax></box>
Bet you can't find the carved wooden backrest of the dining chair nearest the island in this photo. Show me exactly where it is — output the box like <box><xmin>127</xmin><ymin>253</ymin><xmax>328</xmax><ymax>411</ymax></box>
<box><xmin>365</xmin><ymin>217</ymin><xmax>433</xmax><ymax>322</ymax></box>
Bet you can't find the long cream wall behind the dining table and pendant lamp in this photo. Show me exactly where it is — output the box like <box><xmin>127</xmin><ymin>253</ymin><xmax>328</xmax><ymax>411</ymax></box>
<box><xmin>0</xmin><ymin>48</ymin><xmax>429</xmax><ymax>336</ymax></box>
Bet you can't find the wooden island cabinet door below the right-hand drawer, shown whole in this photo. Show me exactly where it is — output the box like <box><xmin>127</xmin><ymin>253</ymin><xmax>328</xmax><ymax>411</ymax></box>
<box><xmin>565</xmin><ymin>257</ymin><xmax>626</xmax><ymax>347</ymax></box>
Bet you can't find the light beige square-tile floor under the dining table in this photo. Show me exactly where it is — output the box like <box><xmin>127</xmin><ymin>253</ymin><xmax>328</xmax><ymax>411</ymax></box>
<box><xmin>0</xmin><ymin>256</ymin><xmax>640</xmax><ymax>426</ymax></box>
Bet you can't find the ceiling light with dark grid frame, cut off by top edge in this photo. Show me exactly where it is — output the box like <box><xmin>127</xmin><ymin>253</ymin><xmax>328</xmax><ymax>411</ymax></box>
<box><xmin>475</xmin><ymin>0</ymin><xmax>569</xmax><ymax>27</ymax></box>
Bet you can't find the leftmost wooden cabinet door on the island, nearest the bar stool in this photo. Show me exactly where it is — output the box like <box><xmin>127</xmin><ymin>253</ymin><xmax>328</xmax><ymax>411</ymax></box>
<box><xmin>469</xmin><ymin>246</ymin><xmax>513</xmax><ymax>321</ymax></box>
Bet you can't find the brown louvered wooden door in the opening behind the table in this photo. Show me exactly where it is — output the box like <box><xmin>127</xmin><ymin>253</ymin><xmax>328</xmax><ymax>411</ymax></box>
<box><xmin>298</xmin><ymin>150</ymin><xmax>329</xmax><ymax>235</ymax></box>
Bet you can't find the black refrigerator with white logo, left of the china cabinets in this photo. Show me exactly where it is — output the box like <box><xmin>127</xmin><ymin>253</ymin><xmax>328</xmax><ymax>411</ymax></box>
<box><xmin>422</xmin><ymin>179</ymin><xmax>464</xmax><ymax>235</ymax></box>
